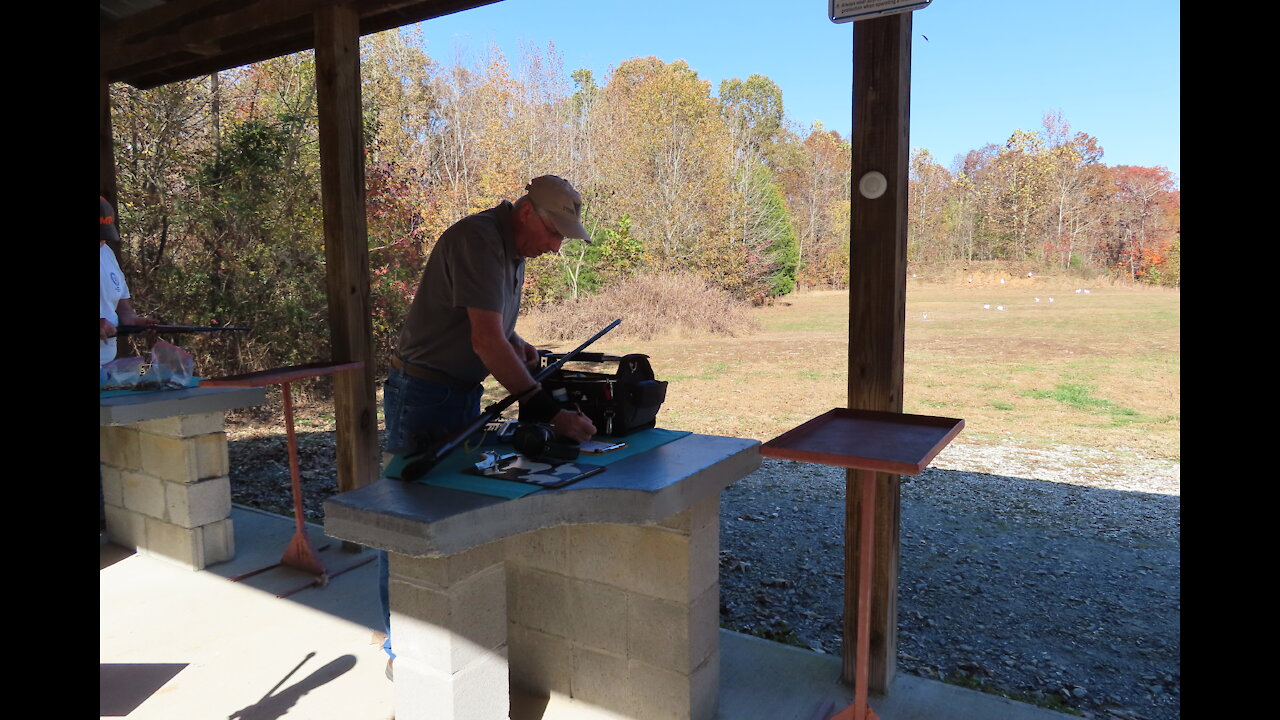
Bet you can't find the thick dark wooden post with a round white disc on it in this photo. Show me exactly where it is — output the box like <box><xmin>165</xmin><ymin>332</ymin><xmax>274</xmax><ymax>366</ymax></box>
<box><xmin>842</xmin><ymin>13</ymin><xmax>911</xmax><ymax>694</ymax></box>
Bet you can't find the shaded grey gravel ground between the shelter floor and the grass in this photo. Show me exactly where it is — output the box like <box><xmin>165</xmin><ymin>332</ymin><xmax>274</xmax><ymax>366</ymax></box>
<box><xmin>229</xmin><ymin>427</ymin><xmax>1181</xmax><ymax>720</ymax></box>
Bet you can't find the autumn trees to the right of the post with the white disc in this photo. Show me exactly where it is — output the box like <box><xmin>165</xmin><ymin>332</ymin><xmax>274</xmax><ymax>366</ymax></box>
<box><xmin>908</xmin><ymin>113</ymin><xmax>1181</xmax><ymax>286</ymax></box>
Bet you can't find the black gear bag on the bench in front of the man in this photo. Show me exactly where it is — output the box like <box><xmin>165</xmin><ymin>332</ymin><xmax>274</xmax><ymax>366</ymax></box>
<box><xmin>521</xmin><ymin>352</ymin><xmax>667</xmax><ymax>437</ymax></box>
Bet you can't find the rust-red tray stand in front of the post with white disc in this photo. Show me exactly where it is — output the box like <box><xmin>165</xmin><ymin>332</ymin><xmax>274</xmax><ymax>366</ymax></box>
<box><xmin>760</xmin><ymin>407</ymin><xmax>964</xmax><ymax>720</ymax></box>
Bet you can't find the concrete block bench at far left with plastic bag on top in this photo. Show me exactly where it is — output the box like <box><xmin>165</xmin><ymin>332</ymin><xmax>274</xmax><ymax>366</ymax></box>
<box><xmin>99</xmin><ymin>388</ymin><xmax>266</xmax><ymax>570</ymax></box>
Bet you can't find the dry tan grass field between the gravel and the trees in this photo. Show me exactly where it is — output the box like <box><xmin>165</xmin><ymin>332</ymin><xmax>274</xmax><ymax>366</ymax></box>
<box><xmin>517</xmin><ymin>277</ymin><xmax>1181</xmax><ymax>462</ymax></box>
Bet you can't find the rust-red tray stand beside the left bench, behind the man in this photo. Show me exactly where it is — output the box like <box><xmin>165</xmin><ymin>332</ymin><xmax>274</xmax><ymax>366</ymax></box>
<box><xmin>200</xmin><ymin>361</ymin><xmax>374</xmax><ymax>597</ymax></box>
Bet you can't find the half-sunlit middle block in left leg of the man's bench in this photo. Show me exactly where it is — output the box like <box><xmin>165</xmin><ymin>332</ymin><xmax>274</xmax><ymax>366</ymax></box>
<box><xmin>390</xmin><ymin>565</ymin><xmax>507</xmax><ymax>673</ymax></box>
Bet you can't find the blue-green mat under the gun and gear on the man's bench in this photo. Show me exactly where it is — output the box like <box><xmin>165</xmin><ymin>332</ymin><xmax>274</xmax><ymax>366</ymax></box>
<box><xmin>383</xmin><ymin>428</ymin><xmax>690</xmax><ymax>500</ymax></box>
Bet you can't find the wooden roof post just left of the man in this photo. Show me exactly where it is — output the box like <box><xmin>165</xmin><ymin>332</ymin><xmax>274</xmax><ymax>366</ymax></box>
<box><xmin>315</xmin><ymin>4</ymin><xmax>379</xmax><ymax>492</ymax></box>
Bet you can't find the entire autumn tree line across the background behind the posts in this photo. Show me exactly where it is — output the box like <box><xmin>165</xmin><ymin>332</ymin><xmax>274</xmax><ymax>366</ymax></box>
<box><xmin>111</xmin><ymin>27</ymin><xmax>1178</xmax><ymax>372</ymax></box>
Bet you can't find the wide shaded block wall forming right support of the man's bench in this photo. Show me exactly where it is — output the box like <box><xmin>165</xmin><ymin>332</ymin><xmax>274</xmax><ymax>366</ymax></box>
<box><xmin>507</xmin><ymin>495</ymin><xmax>719</xmax><ymax>720</ymax></box>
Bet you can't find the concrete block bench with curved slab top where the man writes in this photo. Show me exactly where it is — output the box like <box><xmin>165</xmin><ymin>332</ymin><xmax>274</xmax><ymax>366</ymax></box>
<box><xmin>325</xmin><ymin>434</ymin><xmax>760</xmax><ymax>720</ymax></box>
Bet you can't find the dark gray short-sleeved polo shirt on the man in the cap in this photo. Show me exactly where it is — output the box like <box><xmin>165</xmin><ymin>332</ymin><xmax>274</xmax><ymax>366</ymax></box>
<box><xmin>399</xmin><ymin>200</ymin><xmax>525</xmax><ymax>383</ymax></box>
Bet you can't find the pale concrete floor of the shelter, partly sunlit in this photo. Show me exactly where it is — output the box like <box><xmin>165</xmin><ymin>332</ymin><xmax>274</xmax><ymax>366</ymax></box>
<box><xmin>99</xmin><ymin>506</ymin><xmax>1071</xmax><ymax>720</ymax></box>
